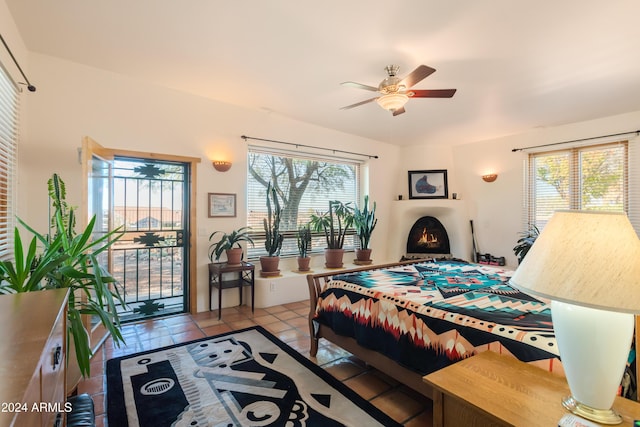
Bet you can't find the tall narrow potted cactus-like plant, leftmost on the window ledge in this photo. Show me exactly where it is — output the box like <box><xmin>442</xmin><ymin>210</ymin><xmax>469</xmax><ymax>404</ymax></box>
<box><xmin>260</xmin><ymin>182</ymin><xmax>284</xmax><ymax>277</ymax></box>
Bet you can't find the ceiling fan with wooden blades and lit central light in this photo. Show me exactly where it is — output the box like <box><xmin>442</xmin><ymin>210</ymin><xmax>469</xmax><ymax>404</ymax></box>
<box><xmin>341</xmin><ymin>65</ymin><xmax>456</xmax><ymax>116</ymax></box>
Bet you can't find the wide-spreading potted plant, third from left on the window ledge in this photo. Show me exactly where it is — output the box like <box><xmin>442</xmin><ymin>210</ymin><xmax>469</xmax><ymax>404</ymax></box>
<box><xmin>310</xmin><ymin>200</ymin><xmax>353</xmax><ymax>268</ymax></box>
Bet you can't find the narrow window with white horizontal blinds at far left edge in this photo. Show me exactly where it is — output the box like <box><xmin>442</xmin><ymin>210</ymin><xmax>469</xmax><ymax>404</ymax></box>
<box><xmin>0</xmin><ymin>64</ymin><xmax>19</xmax><ymax>259</ymax></box>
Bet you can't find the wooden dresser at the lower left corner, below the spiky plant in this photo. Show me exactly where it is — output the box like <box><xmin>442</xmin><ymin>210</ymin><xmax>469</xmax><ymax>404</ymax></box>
<box><xmin>0</xmin><ymin>289</ymin><xmax>68</xmax><ymax>427</ymax></box>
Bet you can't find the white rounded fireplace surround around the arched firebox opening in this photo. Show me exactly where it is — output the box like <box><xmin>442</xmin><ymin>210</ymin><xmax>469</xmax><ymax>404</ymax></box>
<box><xmin>389</xmin><ymin>199</ymin><xmax>473</xmax><ymax>261</ymax></box>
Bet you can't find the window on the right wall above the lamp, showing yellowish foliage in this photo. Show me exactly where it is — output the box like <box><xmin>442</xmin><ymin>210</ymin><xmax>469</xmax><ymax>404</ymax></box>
<box><xmin>527</xmin><ymin>141</ymin><xmax>629</xmax><ymax>229</ymax></box>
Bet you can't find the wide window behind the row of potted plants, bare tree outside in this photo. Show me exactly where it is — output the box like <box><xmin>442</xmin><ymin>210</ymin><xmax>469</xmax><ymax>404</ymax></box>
<box><xmin>247</xmin><ymin>146</ymin><xmax>360</xmax><ymax>258</ymax></box>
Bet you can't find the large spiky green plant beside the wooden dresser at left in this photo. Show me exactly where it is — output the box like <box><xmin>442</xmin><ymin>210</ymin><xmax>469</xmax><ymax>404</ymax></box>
<box><xmin>0</xmin><ymin>174</ymin><xmax>125</xmax><ymax>378</ymax></box>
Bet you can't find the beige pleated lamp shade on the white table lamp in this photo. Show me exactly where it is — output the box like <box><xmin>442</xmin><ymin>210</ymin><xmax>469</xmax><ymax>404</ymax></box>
<box><xmin>510</xmin><ymin>211</ymin><xmax>640</xmax><ymax>313</ymax></box>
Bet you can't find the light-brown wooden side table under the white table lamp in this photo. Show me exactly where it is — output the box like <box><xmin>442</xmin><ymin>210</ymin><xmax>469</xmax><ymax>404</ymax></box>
<box><xmin>423</xmin><ymin>351</ymin><xmax>640</xmax><ymax>427</ymax></box>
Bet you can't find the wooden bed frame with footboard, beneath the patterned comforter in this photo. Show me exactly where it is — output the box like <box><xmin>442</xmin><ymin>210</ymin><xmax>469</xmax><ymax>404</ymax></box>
<box><xmin>307</xmin><ymin>259</ymin><xmax>640</xmax><ymax>401</ymax></box>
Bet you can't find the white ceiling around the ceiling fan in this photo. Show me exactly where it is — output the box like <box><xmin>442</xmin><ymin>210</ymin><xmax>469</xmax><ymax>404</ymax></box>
<box><xmin>6</xmin><ymin>0</ymin><xmax>640</xmax><ymax>145</ymax></box>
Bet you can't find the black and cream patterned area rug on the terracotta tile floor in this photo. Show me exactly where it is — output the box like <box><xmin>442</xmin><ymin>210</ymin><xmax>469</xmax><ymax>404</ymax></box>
<box><xmin>107</xmin><ymin>326</ymin><xmax>399</xmax><ymax>427</ymax></box>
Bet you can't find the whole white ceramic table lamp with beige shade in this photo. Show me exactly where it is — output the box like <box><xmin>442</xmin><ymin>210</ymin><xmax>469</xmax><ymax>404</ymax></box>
<box><xmin>510</xmin><ymin>211</ymin><xmax>640</xmax><ymax>424</ymax></box>
